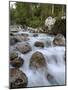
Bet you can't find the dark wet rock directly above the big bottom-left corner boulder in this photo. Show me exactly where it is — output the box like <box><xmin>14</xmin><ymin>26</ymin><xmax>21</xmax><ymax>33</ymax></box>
<box><xmin>10</xmin><ymin>57</ymin><xmax>24</xmax><ymax>68</ymax></box>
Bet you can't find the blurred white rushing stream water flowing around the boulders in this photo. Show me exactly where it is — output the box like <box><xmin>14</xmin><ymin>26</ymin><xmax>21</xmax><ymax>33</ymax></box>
<box><xmin>10</xmin><ymin>31</ymin><xmax>65</xmax><ymax>87</ymax></box>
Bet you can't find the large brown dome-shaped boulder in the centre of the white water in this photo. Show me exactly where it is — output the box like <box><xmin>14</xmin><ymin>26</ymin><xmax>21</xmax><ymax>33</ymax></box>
<box><xmin>29</xmin><ymin>51</ymin><xmax>46</xmax><ymax>69</ymax></box>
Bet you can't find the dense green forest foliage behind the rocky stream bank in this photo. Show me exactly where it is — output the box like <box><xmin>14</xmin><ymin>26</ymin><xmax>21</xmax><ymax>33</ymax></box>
<box><xmin>10</xmin><ymin>2</ymin><xmax>65</xmax><ymax>28</ymax></box>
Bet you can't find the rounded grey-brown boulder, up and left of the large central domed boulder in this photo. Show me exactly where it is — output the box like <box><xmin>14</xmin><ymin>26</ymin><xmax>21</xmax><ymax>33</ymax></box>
<box><xmin>16</xmin><ymin>43</ymin><xmax>32</xmax><ymax>54</ymax></box>
